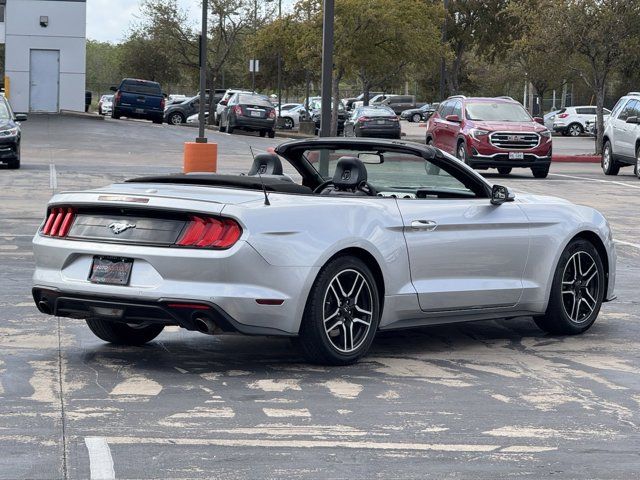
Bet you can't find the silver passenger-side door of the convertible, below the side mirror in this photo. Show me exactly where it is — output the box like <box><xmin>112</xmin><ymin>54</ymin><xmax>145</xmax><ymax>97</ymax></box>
<box><xmin>397</xmin><ymin>163</ymin><xmax>530</xmax><ymax>312</ymax></box>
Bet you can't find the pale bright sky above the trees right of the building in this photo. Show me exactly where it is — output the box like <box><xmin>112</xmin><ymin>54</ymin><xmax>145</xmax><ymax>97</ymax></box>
<box><xmin>87</xmin><ymin>0</ymin><xmax>201</xmax><ymax>42</ymax></box>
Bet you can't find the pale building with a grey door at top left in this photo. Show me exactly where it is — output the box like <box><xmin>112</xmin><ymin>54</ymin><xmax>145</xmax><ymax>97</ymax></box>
<box><xmin>0</xmin><ymin>0</ymin><xmax>86</xmax><ymax>112</ymax></box>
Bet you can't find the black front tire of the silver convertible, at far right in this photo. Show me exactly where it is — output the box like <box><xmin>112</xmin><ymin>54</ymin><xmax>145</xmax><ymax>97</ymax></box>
<box><xmin>534</xmin><ymin>238</ymin><xmax>605</xmax><ymax>335</ymax></box>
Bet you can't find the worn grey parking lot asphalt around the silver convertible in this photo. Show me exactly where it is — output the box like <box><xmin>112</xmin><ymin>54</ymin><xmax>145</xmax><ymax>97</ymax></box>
<box><xmin>0</xmin><ymin>116</ymin><xmax>640</xmax><ymax>479</ymax></box>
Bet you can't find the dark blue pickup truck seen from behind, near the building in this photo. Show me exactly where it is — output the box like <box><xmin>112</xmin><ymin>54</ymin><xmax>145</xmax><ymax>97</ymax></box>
<box><xmin>111</xmin><ymin>78</ymin><xmax>164</xmax><ymax>123</ymax></box>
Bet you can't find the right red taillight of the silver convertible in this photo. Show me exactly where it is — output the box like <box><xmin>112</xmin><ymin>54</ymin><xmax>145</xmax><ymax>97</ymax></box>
<box><xmin>176</xmin><ymin>216</ymin><xmax>242</xmax><ymax>249</ymax></box>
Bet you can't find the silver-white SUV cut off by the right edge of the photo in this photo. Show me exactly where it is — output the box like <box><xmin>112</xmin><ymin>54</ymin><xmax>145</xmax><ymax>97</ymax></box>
<box><xmin>602</xmin><ymin>92</ymin><xmax>640</xmax><ymax>178</ymax></box>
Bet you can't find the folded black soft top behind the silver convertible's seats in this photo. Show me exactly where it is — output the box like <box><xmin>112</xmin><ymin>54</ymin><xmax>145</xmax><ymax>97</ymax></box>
<box><xmin>126</xmin><ymin>173</ymin><xmax>313</xmax><ymax>195</ymax></box>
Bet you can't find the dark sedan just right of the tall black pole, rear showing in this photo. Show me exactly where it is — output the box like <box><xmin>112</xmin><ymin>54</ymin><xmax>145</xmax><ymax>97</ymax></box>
<box><xmin>344</xmin><ymin>105</ymin><xmax>401</xmax><ymax>138</ymax></box>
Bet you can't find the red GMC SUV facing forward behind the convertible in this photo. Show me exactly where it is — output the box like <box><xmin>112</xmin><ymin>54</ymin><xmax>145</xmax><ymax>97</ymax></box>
<box><xmin>426</xmin><ymin>95</ymin><xmax>551</xmax><ymax>178</ymax></box>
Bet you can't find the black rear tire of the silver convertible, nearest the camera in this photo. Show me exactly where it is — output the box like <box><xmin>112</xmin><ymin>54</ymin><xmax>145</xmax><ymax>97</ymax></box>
<box><xmin>298</xmin><ymin>256</ymin><xmax>380</xmax><ymax>365</ymax></box>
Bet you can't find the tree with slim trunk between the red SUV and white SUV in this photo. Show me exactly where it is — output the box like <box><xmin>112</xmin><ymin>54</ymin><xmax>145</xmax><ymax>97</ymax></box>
<box><xmin>543</xmin><ymin>0</ymin><xmax>640</xmax><ymax>154</ymax></box>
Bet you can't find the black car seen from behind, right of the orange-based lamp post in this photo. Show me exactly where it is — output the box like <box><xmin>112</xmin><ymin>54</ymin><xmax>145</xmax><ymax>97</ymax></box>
<box><xmin>220</xmin><ymin>93</ymin><xmax>276</xmax><ymax>138</ymax></box>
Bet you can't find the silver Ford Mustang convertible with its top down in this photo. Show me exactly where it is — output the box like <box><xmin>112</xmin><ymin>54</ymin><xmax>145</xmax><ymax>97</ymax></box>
<box><xmin>33</xmin><ymin>138</ymin><xmax>616</xmax><ymax>364</ymax></box>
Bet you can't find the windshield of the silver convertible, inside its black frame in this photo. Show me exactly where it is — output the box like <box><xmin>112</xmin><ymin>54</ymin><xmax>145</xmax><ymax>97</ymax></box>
<box><xmin>303</xmin><ymin>149</ymin><xmax>475</xmax><ymax>198</ymax></box>
